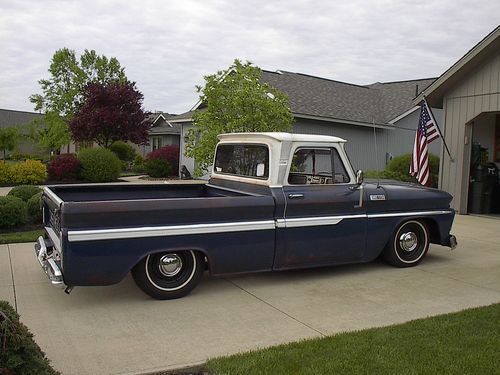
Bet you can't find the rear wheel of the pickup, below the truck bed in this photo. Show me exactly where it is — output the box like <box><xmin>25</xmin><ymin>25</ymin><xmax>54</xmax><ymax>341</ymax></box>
<box><xmin>132</xmin><ymin>250</ymin><xmax>204</xmax><ymax>299</ymax></box>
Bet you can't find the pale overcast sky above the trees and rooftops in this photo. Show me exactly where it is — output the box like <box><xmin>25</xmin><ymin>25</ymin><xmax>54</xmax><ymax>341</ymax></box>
<box><xmin>0</xmin><ymin>0</ymin><xmax>500</xmax><ymax>113</ymax></box>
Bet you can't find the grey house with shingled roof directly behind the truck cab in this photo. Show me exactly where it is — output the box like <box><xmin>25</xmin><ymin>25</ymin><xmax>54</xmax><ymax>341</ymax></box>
<box><xmin>168</xmin><ymin>70</ymin><xmax>441</xmax><ymax>176</ymax></box>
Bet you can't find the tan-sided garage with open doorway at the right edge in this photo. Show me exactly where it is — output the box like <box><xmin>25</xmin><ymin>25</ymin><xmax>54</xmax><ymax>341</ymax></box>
<box><xmin>414</xmin><ymin>26</ymin><xmax>500</xmax><ymax>214</ymax></box>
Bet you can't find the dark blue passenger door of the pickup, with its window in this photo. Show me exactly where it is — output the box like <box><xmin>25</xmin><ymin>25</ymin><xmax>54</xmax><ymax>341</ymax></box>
<box><xmin>274</xmin><ymin>147</ymin><xmax>367</xmax><ymax>269</ymax></box>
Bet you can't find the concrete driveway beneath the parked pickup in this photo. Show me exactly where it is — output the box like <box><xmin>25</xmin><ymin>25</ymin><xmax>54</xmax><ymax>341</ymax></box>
<box><xmin>0</xmin><ymin>216</ymin><xmax>500</xmax><ymax>374</ymax></box>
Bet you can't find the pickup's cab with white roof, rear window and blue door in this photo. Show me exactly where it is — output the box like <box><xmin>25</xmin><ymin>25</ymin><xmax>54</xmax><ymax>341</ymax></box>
<box><xmin>210</xmin><ymin>133</ymin><xmax>366</xmax><ymax>269</ymax></box>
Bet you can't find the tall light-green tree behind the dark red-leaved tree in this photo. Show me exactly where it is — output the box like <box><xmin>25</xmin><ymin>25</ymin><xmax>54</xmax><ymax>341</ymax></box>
<box><xmin>29</xmin><ymin>48</ymin><xmax>127</xmax><ymax>151</ymax></box>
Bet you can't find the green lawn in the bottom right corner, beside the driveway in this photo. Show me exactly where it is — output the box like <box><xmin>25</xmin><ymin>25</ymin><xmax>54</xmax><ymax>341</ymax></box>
<box><xmin>205</xmin><ymin>304</ymin><xmax>500</xmax><ymax>375</ymax></box>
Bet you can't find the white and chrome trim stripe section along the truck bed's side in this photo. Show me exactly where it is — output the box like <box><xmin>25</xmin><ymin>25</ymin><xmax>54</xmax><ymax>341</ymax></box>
<box><xmin>68</xmin><ymin>220</ymin><xmax>276</xmax><ymax>242</ymax></box>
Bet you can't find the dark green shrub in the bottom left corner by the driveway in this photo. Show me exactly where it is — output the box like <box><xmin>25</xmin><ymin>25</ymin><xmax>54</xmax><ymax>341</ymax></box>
<box><xmin>0</xmin><ymin>301</ymin><xmax>59</xmax><ymax>375</ymax></box>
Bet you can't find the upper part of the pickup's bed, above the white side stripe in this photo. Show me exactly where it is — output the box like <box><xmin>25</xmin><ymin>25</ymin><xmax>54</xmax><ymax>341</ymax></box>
<box><xmin>44</xmin><ymin>184</ymin><xmax>274</xmax><ymax>233</ymax></box>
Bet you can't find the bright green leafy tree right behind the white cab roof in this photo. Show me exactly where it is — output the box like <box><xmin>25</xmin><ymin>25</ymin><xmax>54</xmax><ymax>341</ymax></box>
<box><xmin>186</xmin><ymin>60</ymin><xmax>293</xmax><ymax>175</ymax></box>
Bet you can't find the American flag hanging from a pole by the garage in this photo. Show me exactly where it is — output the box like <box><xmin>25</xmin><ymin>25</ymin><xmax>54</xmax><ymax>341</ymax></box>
<box><xmin>410</xmin><ymin>100</ymin><xmax>439</xmax><ymax>186</ymax></box>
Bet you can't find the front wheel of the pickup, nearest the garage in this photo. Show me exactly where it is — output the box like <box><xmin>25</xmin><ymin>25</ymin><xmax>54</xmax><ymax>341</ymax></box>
<box><xmin>382</xmin><ymin>220</ymin><xmax>429</xmax><ymax>267</ymax></box>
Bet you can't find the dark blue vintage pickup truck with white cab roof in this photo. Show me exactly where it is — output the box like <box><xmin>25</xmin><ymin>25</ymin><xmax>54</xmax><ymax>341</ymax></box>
<box><xmin>35</xmin><ymin>133</ymin><xmax>456</xmax><ymax>299</ymax></box>
